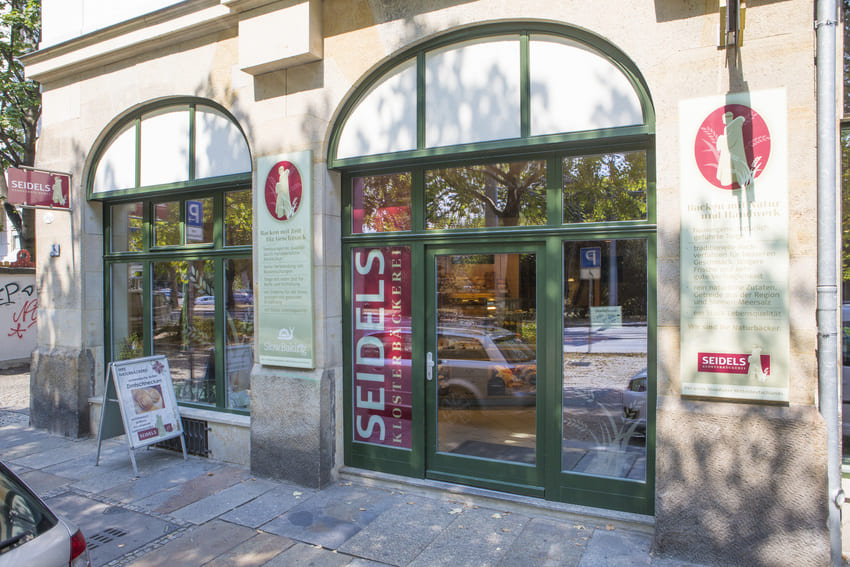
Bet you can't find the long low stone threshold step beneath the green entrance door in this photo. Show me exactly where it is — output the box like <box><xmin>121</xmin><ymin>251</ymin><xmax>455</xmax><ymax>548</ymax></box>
<box><xmin>339</xmin><ymin>466</ymin><xmax>655</xmax><ymax>535</ymax></box>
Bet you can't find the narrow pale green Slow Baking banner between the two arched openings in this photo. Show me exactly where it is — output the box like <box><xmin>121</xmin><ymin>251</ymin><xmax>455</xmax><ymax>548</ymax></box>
<box><xmin>255</xmin><ymin>151</ymin><xmax>315</xmax><ymax>368</ymax></box>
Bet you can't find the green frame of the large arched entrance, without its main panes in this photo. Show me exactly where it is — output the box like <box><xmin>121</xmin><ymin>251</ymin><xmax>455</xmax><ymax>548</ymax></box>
<box><xmin>328</xmin><ymin>21</ymin><xmax>657</xmax><ymax>514</ymax></box>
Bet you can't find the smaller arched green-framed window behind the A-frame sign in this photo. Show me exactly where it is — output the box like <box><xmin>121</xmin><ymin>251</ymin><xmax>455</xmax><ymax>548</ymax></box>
<box><xmin>87</xmin><ymin>99</ymin><xmax>254</xmax><ymax>412</ymax></box>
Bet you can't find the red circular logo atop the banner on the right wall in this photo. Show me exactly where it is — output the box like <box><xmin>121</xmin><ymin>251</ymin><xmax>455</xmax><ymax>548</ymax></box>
<box><xmin>694</xmin><ymin>104</ymin><xmax>770</xmax><ymax>190</ymax></box>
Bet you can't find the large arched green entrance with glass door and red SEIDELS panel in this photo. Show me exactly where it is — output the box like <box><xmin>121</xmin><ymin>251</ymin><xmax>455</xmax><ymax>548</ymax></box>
<box><xmin>329</xmin><ymin>24</ymin><xmax>655</xmax><ymax>514</ymax></box>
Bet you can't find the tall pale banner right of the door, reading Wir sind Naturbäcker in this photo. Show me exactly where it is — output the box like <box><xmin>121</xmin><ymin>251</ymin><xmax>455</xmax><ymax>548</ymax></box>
<box><xmin>679</xmin><ymin>89</ymin><xmax>790</xmax><ymax>402</ymax></box>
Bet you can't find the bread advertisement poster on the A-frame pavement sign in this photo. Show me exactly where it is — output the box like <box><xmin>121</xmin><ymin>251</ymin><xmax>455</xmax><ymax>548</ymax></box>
<box><xmin>111</xmin><ymin>356</ymin><xmax>182</xmax><ymax>449</ymax></box>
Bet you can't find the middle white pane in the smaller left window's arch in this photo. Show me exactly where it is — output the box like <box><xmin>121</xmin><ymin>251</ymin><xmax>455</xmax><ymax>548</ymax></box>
<box><xmin>140</xmin><ymin>107</ymin><xmax>189</xmax><ymax>187</ymax></box>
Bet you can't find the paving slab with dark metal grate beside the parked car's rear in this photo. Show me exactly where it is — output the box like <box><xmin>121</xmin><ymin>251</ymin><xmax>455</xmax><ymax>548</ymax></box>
<box><xmin>46</xmin><ymin>493</ymin><xmax>177</xmax><ymax>565</ymax></box>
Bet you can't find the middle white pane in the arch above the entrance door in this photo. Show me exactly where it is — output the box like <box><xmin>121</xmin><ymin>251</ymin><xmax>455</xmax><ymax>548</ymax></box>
<box><xmin>425</xmin><ymin>36</ymin><xmax>520</xmax><ymax>148</ymax></box>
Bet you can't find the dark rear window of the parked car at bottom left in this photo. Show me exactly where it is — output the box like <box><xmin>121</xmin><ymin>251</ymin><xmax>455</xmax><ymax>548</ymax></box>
<box><xmin>0</xmin><ymin>464</ymin><xmax>57</xmax><ymax>554</ymax></box>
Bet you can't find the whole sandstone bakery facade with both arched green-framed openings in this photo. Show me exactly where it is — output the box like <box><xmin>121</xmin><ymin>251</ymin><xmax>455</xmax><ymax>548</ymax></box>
<box><xmin>25</xmin><ymin>0</ymin><xmax>838</xmax><ymax>565</ymax></box>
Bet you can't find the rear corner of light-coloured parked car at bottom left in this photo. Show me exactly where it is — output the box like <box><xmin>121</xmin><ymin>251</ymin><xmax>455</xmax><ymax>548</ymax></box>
<box><xmin>0</xmin><ymin>463</ymin><xmax>91</xmax><ymax>567</ymax></box>
